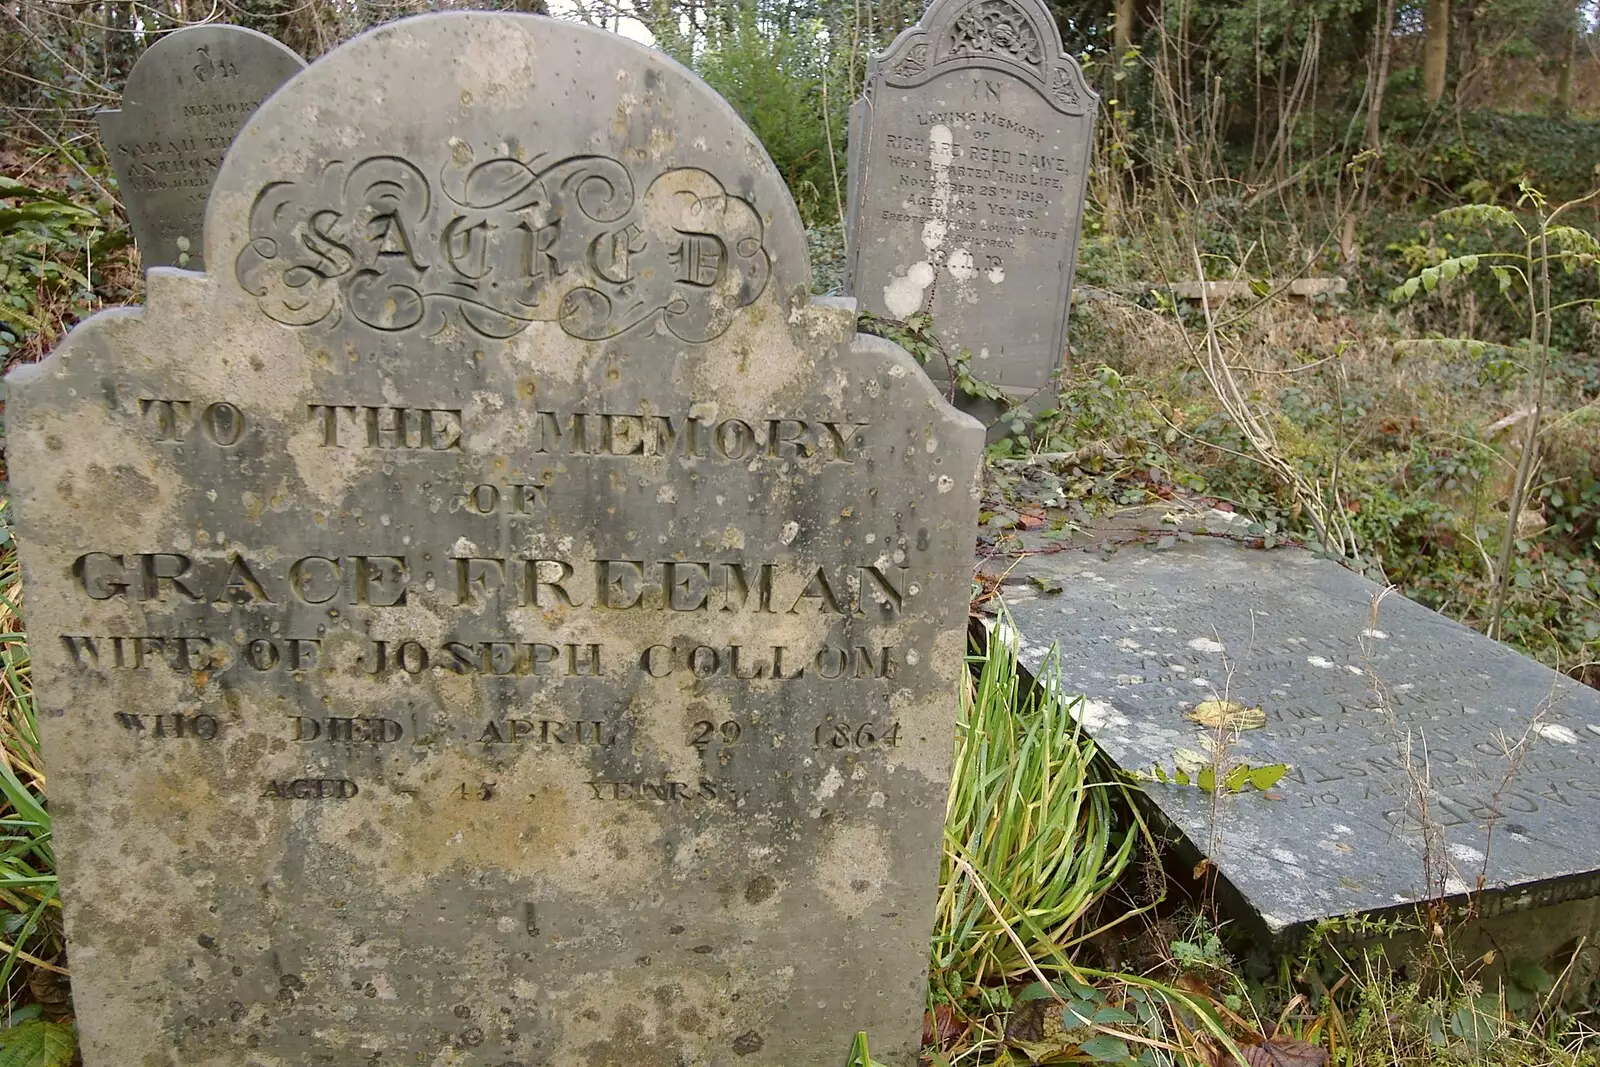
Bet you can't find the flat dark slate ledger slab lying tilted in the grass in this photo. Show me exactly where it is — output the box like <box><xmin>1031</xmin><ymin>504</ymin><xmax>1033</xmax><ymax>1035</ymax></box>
<box><xmin>1006</xmin><ymin>539</ymin><xmax>1600</xmax><ymax>941</ymax></box>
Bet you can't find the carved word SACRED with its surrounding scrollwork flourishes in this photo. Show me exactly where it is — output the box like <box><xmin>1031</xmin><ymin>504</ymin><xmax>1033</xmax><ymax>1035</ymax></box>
<box><xmin>234</xmin><ymin>142</ymin><xmax>771</xmax><ymax>342</ymax></box>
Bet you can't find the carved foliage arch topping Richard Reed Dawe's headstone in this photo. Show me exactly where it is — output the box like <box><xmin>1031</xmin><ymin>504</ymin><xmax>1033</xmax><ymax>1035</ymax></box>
<box><xmin>867</xmin><ymin>0</ymin><xmax>1099</xmax><ymax>115</ymax></box>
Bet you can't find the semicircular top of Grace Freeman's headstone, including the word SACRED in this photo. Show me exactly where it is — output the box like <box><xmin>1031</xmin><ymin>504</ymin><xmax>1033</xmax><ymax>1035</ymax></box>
<box><xmin>206</xmin><ymin>13</ymin><xmax>810</xmax><ymax>344</ymax></box>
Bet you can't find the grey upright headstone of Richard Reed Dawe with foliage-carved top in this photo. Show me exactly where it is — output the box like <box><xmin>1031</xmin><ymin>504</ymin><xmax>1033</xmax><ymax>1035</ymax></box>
<box><xmin>846</xmin><ymin>0</ymin><xmax>1099</xmax><ymax>403</ymax></box>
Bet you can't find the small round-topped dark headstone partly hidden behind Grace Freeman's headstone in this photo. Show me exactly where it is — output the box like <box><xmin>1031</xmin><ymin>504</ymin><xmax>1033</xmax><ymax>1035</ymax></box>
<box><xmin>98</xmin><ymin>26</ymin><xmax>306</xmax><ymax>270</ymax></box>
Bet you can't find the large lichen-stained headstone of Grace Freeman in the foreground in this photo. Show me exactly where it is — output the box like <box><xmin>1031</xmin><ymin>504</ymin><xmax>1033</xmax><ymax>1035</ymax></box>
<box><xmin>8</xmin><ymin>13</ymin><xmax>982</xmax><ymax>1067</ymax></box>
